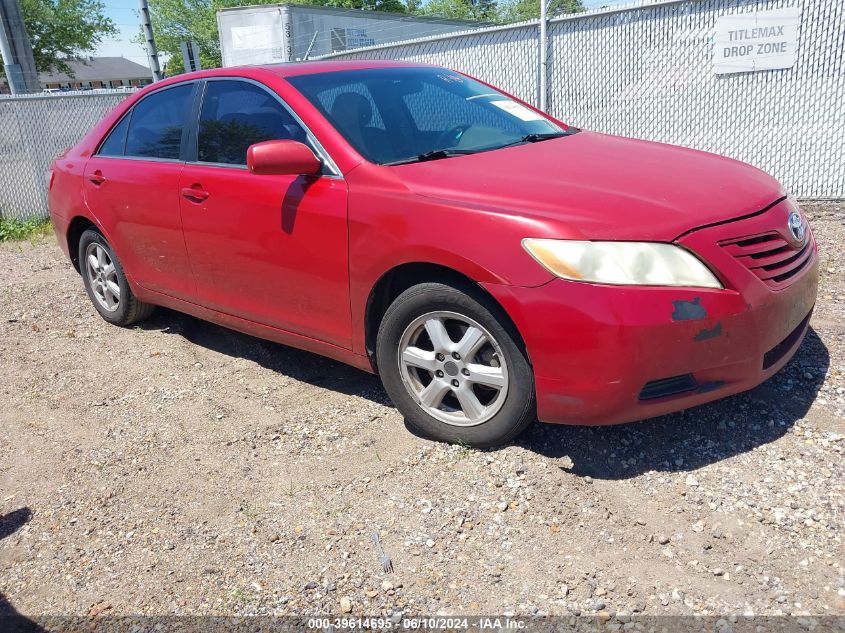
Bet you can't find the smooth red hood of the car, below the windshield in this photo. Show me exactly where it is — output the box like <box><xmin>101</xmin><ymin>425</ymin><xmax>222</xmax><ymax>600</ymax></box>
<box><xmin>392</xmin><ymin>132</ymin><xmax>785</xmax><ymax>241</ymax></box>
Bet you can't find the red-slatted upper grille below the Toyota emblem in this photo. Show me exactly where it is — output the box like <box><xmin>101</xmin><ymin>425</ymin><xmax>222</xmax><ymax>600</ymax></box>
<box><xmin>719</xmin><ymin>232</ymin><xmax>813</xmax><ymax>288</ymax></box>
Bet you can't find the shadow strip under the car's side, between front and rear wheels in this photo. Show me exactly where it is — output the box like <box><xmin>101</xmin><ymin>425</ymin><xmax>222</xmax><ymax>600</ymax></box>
<box><xmin>137</xmin><ymin>308</ymin><xmax>392</xmax><ymax>406</ymax></box>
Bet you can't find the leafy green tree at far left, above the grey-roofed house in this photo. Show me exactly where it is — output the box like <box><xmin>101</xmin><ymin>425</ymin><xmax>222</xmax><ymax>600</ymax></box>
<box><xmin>0</xmin><ymin>0</ymin><xmax>117</xmax><ymax>75</ymax></box>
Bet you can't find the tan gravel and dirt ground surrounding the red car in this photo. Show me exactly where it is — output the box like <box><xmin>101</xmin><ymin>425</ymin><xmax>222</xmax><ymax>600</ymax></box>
<box><xmin>0</xmin><ymin>204</ymin><xmax>845</xmax><ymax>622</ymax></box>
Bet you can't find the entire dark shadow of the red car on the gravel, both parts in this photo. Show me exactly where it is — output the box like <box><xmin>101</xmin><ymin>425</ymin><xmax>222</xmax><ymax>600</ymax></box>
<box><xmin>139</xmin><ymin>308</ymin><xmax>830</xmax><ymax>480</ymax></box>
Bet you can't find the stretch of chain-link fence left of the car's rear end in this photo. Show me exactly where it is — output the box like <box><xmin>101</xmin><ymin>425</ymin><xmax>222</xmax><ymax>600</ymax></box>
<box><xmin>0</xmin><ymin>91</ymin><xmax>128</xmax><ymax>220</ymax></box>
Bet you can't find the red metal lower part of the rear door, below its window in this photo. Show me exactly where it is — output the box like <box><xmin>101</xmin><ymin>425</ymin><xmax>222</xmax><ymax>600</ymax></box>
<box><xmin>83</xmin><ymin>156</ymin><xmax>194</xmax><ymax>298</ymax></box>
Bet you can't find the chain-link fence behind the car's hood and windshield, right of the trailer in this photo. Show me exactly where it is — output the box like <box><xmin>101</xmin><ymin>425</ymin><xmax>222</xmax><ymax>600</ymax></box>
<box><xmin>323</xmin><ymin>0</ymin><xmax>845</xmax><ymax>198</ymax></box>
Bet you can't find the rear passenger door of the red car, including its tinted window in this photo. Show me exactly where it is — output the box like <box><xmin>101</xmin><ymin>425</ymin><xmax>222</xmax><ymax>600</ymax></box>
<box><xmin>83</xmin><ymin>83</ymin><xmax>197</xmax><ymax>298</ymax></box>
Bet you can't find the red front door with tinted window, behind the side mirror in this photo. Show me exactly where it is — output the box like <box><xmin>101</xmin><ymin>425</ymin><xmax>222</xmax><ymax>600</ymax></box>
<box><xmin>179</xmin><ymin>79</ymin><xmax>351</xmax><ymax>348</ymax></box>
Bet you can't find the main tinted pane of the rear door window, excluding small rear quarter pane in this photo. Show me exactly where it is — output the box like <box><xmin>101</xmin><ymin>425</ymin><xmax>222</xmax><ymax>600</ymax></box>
<box><xmin>126</xmin><ymin>84</ymin><xmax>194</xmax><ymax>159</ymax></box>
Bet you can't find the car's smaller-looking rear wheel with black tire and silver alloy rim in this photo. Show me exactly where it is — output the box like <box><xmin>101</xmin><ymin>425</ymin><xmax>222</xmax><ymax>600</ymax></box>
<box><xmin>79</xmin><ymin>229</ymin><xmax>155</xmax><ymax>326</ymax></box>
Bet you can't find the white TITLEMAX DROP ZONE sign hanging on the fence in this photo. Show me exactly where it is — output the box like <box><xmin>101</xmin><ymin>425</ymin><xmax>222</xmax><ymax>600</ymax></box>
<box><xmin>713</xmin><ymin>7</ymin><xmax>801</xmax><ymax>75</ymax></box>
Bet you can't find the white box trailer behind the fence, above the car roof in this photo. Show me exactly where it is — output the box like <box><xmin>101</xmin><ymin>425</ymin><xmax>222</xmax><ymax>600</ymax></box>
<box><xmin>217</xmin><ymin>4</ymin><xmax>483</xmax><ymax>66</ymax></box>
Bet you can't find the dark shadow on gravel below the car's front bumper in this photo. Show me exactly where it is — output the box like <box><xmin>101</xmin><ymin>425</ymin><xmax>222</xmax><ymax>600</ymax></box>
<box><xmin>517</xmin><ymin>328</ymin><xmax>830</xmax><ymax>480</ymax></box>
